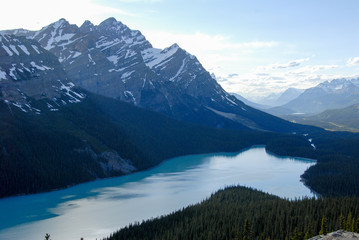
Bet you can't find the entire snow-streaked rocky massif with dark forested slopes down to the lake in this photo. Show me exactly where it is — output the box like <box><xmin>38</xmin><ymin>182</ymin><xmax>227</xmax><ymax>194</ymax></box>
<box><xmin>0</xmin><ymin>19</ymin><xmax>358</xmax><ymax>201</ymax></box>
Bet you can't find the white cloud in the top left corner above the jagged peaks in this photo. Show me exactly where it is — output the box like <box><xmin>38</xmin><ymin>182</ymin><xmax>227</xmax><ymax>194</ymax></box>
<box><xmin>0</xmin><ymin>0</ymin><xmax>137</xmax><ymax>30</ymax></box>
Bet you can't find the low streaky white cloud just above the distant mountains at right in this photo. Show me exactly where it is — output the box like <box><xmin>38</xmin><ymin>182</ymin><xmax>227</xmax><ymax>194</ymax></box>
<box><xmin>218</xmin><ymin>62</ymin><xmax>353</xmax><ymax>101</ymax></box>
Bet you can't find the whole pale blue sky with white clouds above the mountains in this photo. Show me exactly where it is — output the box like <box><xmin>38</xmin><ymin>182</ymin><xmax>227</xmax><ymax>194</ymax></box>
<box><xmin>0</xmin><ymin>0</ymin><xmax>359</xmax><ymax>101</ymax></box>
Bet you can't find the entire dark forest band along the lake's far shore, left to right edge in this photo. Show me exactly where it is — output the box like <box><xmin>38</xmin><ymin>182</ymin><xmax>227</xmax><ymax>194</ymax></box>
<box><xmin>0</xmin><ymin>89</ymin><xmax>359</xmax><ymax>197</ymax></box>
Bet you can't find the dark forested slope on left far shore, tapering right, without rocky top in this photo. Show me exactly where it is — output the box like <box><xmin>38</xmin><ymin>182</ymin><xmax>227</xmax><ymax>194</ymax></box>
<box><xmin>0</xmin><ymin>93</ymin><xmax>275</xmax><ymax>197</ymax></box>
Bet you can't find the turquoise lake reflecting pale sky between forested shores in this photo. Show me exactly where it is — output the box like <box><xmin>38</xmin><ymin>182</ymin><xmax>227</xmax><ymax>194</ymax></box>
<box><xmin>0</xmin><ymin>147</ymin><xmax>314</xmax><ymax>240</ymax></box>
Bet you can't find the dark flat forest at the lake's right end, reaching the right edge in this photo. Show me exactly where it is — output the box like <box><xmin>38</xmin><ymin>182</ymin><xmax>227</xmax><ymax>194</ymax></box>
<box><xmin>266</xmin><ymin>130</ymin><xmax>359</xmax><ymax>197</ymax></box>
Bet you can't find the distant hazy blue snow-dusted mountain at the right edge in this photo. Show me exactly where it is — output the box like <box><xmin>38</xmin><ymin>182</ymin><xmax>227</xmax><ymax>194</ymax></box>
<box><xmin>274</xmin><ymin>79</ymin><xmax>359</xmax><ymax>114</ymax></box>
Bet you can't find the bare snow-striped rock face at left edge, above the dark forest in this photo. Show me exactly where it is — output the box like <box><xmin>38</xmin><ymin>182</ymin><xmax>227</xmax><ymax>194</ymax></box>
<box><xmin>0</xmin><ymin>33</ymin><xmax>84</xmax><ymax>114</ymax></box>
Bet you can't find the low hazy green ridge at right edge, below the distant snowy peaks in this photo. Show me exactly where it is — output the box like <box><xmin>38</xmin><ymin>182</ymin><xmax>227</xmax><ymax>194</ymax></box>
<box><xmin>284</xmin><ymin>104</ymin><xmax>359</xmax><ymax>132</ymax></box>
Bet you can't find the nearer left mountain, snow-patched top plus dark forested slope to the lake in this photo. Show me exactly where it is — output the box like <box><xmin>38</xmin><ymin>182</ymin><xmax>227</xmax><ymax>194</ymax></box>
<box><xmin>0</xmin><ymin>33</ymin><xmax>288</xmax><ymax>197</ymax></box>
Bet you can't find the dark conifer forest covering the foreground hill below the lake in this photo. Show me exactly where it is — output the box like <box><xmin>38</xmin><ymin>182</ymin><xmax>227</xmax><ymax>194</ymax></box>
<box><xmin>106</xmin><ymin>187</ymin><xmax>359</xmax><ymax>240</ymax></box>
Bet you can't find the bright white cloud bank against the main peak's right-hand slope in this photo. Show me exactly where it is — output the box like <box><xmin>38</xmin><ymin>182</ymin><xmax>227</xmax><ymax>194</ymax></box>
<box><xmin>141</xmin><ymin>30</ymin><xmax>280</xmax><ymax>75</ymax></box>
